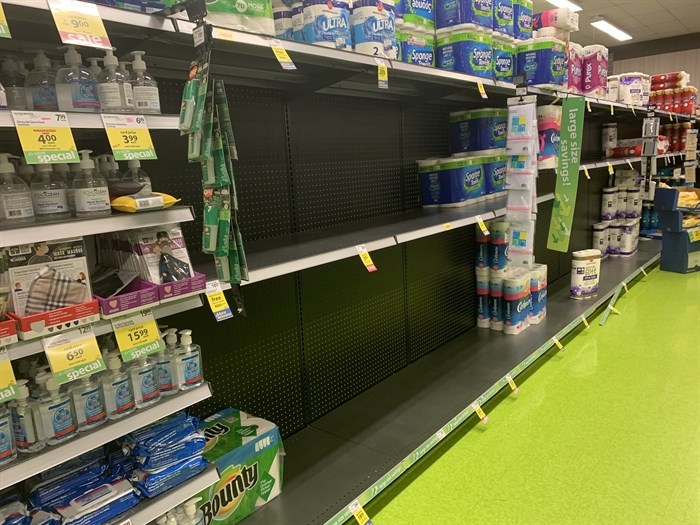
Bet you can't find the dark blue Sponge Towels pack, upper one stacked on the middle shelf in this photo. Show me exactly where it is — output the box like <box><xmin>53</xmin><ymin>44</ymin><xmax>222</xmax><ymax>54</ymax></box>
<box><xmin>450</xmin><ymin>108</ymin><xmax>508</xmax><ymax>154</ymax></box>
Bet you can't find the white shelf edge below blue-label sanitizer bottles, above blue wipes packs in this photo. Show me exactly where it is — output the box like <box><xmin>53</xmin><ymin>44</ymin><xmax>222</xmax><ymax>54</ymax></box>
<box><xmin>0</xmin><ymin>383</ymin><xmax>211</xmax><ymax>489</ymax></box>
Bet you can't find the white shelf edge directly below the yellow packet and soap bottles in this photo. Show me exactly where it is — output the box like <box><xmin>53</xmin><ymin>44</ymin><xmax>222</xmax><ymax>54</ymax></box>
<box><xmin>0</xmin><ymin>206</ymin><xmax>194</xmax><ymax>247</ymax></box>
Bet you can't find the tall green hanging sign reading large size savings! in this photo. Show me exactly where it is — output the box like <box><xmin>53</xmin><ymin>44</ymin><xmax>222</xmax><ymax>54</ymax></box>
<box><xmin>547</xmin><ymin>96</ymin><xmax>584</xmax><ymax>253</ymax></box>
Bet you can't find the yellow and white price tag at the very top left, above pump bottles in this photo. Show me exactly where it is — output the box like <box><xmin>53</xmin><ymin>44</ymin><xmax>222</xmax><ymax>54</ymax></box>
<box><xmin>48</xmin><ymin>0</ymin><xmax>112</xmax><ymax>49</ymax></box>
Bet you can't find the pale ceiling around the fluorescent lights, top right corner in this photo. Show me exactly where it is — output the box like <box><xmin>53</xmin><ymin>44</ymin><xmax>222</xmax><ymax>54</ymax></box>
<box><xmin>533</xmin><ymin>0</ymin><xmax>700</xmax><ymax>47</ymax></box>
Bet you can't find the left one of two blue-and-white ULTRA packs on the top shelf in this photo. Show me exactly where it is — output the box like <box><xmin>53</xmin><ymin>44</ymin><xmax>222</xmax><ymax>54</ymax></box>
<box><xmin>304</xmin><ymin>0</ymin><xmax>352</xmax><ymax>50</ymax></box>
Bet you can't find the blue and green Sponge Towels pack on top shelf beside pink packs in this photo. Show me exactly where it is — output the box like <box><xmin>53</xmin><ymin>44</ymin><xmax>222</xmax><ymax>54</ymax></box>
<box><xmin>517</xmin><ymin>38</ymin><xmax>568</xmax><ymax>86</ymax></box>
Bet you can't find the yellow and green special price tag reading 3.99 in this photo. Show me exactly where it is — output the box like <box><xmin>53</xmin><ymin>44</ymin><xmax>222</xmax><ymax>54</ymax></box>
<box><xmin>102</xmin><ymin>114</ymin><xmax>158</xmax><ymax>160</ymax></box>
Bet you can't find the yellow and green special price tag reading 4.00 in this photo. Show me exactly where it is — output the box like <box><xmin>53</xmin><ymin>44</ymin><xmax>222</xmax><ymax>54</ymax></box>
<box><xmin>12</xmin><ymin>111</ymin><xmax>80</xmax><ymax>164</ymax></box>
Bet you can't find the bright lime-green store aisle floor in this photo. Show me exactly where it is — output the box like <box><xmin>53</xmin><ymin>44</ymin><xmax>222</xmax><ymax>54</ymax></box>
<box><xmin>366</xmin><ymin>270</ymin><xmax>700</xmax><ymax>525</ymax></box>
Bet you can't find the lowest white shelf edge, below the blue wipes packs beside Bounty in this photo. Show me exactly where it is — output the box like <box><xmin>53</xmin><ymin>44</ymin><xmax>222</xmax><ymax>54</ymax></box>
<box><xmin>107</xmin><ymin>463</ymin><xmax>220</xmax><ymax>525</ymax></box>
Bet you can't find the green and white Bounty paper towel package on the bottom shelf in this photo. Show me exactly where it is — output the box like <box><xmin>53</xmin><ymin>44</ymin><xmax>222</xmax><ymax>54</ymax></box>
<box><xmin>195</xmin><ymin>408</ymin><xmax>284</xmax><ymax>525</ymax></box>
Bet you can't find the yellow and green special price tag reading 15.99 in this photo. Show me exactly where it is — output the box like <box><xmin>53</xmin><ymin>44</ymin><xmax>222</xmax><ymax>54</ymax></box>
<box><xmin>112</xmin><ymin>308</ymin><xmax>165</xmax><ymax>363</ymax></box>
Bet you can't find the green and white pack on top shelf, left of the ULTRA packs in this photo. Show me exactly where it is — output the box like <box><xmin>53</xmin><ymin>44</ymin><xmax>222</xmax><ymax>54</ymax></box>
<box><xmin>207</xmin><ymin>0</ymin><xmax>275</xmax><ymax>35</ymax></box>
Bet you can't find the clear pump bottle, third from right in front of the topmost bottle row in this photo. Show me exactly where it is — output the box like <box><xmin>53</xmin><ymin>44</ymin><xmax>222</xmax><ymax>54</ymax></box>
<box><xmin>56</xmin><ymin>46</ymin><xmax>100</xmax><ymax>113</ymax></box>
